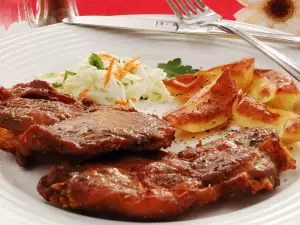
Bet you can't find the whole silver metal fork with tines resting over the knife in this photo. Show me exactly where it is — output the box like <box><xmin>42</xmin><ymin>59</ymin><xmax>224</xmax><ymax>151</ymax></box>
<box><xmin>166</xmin><ymin>0</ymin><xmax>300</xmax><ymax>82</ymax></box>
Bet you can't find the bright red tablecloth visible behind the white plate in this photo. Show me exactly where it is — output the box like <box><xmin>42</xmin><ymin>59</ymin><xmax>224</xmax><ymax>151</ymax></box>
<box><xmin>0</xmin><ymin>0</ymin><xmax>242</xmax><ymax>26</ymax></box>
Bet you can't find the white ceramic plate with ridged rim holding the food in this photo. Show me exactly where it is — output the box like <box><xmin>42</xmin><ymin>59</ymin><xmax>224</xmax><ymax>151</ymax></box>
<box><xmin>0</xmin><ymin>14</ymin><xmax>300</xmax><ymax>225</ymax></box>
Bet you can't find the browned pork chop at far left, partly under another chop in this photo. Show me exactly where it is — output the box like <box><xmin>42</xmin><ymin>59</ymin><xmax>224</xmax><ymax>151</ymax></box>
<box><xmin>0</xmin><ymin>80</ymin><xmax>84</xmax><ymax>154</ymax></box>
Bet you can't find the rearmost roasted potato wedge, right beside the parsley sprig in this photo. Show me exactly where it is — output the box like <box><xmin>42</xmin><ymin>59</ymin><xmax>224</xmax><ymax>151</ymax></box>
<box><xmin>163</xmin><ymin>58</ymin><xmax>255</xmax><ymax>100</ymax></box>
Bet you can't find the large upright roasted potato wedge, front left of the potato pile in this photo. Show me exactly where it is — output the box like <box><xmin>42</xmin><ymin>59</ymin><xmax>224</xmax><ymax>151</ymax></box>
<box><xmin>164</xmin><ymin>67</ymin><xmax>237</xmax><ymax>133</ymax></box>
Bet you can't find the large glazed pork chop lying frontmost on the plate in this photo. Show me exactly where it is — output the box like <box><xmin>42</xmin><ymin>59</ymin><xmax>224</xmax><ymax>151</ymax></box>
<box><xmin>37</xmin><ymin>128</ymin><xmax>296</xmax><ymax>220</ymax></box>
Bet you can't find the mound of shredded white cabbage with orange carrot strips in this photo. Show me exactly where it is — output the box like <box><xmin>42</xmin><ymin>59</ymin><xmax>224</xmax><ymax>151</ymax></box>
<box><xmin>38</xmin><ymin>53</ymin><xmax>171</xmax><ymax>106</ymax></box>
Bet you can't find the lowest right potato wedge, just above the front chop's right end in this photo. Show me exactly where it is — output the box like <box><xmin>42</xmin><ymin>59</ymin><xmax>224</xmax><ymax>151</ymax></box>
<box><xmin>232</xmin><ymin>92</ymin><xmax>300</xmax><ymax>143</ymax></box>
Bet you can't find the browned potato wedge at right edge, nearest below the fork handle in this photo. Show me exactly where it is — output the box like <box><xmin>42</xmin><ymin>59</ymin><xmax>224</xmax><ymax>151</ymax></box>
<box><xmin>248</xmin><ymin>69</ymin><xmax>300</xmax><ymax>111</ymax></box>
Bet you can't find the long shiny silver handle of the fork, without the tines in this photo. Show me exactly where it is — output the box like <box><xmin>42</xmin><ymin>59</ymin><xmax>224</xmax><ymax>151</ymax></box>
<box><xmin>206</xmin><ymin>21</ymin><xmax>300</xmax><ymax>82</ymax></box>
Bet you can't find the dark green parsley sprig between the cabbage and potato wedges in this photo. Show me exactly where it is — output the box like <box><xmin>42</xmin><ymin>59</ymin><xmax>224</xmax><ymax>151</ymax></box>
<box><xmin>157</xmin><ymin>58</ymin><xmax>200</xmax><ymax>78</ymax></box>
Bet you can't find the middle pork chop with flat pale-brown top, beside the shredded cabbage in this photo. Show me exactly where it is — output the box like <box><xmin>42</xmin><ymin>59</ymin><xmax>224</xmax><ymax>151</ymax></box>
<box><xmin>19</xmin><ymin>106</ymin><xmax>175</xmax><ymax>166</ymax></box>
